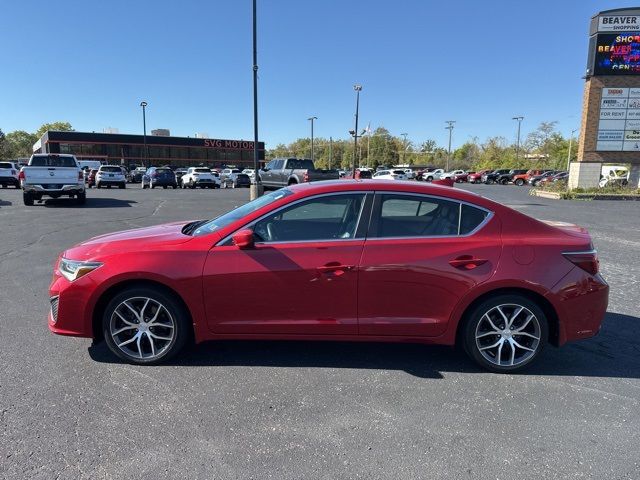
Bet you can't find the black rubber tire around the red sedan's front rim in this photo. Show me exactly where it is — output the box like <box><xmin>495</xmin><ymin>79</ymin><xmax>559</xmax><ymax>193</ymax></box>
<box><xmin>102</xmin><ymin>286</ymin><xmax>193</xmax><ymax>365</ymax></box>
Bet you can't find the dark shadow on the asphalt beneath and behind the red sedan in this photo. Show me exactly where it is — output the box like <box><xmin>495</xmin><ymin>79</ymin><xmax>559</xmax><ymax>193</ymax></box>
<box><xmin>89</xmin><ymin>313</ymin><xmax>640</xmax><ymax>379</ymax></box>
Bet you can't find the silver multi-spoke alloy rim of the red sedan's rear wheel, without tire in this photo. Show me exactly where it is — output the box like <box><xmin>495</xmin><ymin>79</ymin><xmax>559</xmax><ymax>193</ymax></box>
<box><xmin>475</xmin><ymin>303</ymin><xmax>542</xmax><ymax>367</ymax></box>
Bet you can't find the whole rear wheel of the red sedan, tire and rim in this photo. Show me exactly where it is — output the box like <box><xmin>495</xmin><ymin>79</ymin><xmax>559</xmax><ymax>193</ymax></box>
<box><xmin>462</xmin><ymin>295</ymin><xmax>548</xmax><ymax>372</ymax></box>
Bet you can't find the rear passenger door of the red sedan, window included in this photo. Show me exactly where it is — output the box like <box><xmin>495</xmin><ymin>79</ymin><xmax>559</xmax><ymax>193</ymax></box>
<box><xmin>358</xmin><ymin>193</ymin><xmax>501</xmax><ymax>337</ymax></box>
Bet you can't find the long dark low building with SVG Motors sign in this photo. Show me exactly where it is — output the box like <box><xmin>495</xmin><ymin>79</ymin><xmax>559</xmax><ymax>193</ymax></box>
<box><xmin>33</xmin><ymin>130</ymin><xmax>265</xmax><ymax>168</ymax></box>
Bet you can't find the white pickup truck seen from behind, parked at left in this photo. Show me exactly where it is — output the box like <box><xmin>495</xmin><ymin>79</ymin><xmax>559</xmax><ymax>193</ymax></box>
<box><xmin>19</xmin><ymin>153</ymin><xmax>87</xmax><ymax>205</ymax></box>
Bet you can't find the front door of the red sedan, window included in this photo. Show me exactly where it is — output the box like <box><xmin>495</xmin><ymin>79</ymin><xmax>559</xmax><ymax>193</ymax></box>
<box><xmin>203</xmin><ymin>193</ymin><xmax>368</xmax><ymax>335</ymax></box>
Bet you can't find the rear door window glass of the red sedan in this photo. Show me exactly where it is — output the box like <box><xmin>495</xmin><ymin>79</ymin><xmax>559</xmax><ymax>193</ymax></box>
<box><xmin>370</xmin><ymin>194</ymin><xmax>489</xmax><ymax>238</ymax></box>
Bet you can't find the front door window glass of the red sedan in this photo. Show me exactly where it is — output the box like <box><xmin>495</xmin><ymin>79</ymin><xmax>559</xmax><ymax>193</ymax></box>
<box><xmin>253</xmin><ymin>194</ymin><xmax>365</xmax><ymax>242</ymax></box>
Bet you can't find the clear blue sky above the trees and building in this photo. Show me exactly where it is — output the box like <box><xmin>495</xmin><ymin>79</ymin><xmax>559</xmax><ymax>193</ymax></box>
<box><xmin>0</xmin><ymin>0</ymin><xmax>631</xmax><ymax>148</ymax></box>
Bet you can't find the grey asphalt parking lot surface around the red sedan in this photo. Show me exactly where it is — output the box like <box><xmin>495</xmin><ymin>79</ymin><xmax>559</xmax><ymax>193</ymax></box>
<box><xmin>0</xmin><ymin>185</ymin><xmax>640</xmax><ymax>479</ymax></box>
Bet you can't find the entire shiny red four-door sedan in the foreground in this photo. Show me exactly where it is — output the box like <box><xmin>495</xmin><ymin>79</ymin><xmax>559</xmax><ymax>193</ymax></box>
<box><xmin>49</xmin><ymin>180</ymin><xmax>609</xmax><ymax>372</ymax></box>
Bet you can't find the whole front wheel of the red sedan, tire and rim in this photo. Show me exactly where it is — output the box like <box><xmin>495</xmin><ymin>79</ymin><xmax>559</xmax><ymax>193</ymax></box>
<box><xmin>102</xmin><ymin>287</ymin><xmax>192</xmax><ymax>365</ymax></box>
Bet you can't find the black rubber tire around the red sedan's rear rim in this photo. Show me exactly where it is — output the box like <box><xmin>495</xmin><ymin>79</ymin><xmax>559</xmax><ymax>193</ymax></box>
<box><xmin>460</xmin><ymin>294</ymin><xmax>549</xmax><ymax>373</ymax></box>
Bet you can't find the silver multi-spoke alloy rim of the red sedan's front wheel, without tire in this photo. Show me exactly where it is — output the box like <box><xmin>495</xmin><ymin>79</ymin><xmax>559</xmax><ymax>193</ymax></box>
<box><xmin>109</xmin><ymin>297</ymin><xmax>176</xmax><ymax>360</ymax></box>
